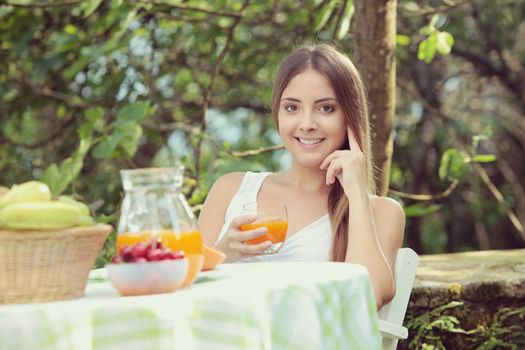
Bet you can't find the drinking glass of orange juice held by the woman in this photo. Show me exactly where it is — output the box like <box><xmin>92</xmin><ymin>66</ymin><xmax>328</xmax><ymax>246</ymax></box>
<box><xmin>240</xmin><ymin>201</ymin><xmax>288</xmax><ymax>254</ymax></box>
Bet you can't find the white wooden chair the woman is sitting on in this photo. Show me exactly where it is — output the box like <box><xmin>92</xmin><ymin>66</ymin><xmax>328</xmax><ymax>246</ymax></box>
<box><xmin>379</xmin><ymin>248</ymin><xmax>419</xmax><ymax>350</ymax></box>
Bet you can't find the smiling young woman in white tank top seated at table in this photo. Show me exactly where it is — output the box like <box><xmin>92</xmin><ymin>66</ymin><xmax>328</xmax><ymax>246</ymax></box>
<box><xmin>199</xmin><ymin>44</ymin><xmax>405</xmax><ymax>308</ymax></box>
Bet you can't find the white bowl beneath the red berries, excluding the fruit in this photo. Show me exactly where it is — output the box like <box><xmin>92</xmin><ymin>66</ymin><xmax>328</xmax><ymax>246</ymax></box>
<box><xmin>106</xmin><ymin>258</ymin><xmax>189</xmax><ymax>296</ymax></box>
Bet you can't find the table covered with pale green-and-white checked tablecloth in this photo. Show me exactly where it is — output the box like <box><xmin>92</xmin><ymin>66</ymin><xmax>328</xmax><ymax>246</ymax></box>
<box><xmin>0</xmin><ymin>262</ymin><xmax>381</xmax><ymax>350</ymax></box>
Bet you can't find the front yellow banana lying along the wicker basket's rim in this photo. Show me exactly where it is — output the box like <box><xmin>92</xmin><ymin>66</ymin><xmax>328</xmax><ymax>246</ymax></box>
<box><xmin>0</xmin><ymin>201</ymin><xmax>82</xmax><ymax>229</ymax></box>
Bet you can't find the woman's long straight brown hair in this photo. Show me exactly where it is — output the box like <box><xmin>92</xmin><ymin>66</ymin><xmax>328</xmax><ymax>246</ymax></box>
<box><xmin>272</xmin><ymin>44</ymin><xmax>375</xmax><ymax>261</ymax></box>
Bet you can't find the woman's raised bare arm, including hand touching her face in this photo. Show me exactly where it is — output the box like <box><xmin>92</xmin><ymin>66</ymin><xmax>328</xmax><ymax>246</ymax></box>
<box><xmin>320</xmin><ymin>129</ymin><xmax>405</xmax><ymax>309</ymax></box>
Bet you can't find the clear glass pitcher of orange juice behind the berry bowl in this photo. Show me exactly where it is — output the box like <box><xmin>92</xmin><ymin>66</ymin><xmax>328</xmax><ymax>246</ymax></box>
<box><xmin>117</xmin><ymin>166</ymin><xmax>204</xmax><ymax>285</ymax></box>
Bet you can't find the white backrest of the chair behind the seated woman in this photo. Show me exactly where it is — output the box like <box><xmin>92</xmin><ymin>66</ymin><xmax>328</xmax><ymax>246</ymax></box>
<box><xmin>379</xmin><ymin>248</ymin><xmax>419</xmax><ymax>325</ymax></box>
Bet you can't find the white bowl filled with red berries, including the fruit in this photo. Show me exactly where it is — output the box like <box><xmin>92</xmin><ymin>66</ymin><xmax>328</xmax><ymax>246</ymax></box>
<box><xmin>106</xmin><ymin>241</ymin><xmax>188</xmax><ymax>296</ymax></box>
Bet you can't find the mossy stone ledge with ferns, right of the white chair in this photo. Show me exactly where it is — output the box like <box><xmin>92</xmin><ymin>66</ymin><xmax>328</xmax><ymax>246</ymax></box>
<box><xmin>398</xmin><ymin>249</ymin><xmax>525</xmax><ymax>350</ymax></box>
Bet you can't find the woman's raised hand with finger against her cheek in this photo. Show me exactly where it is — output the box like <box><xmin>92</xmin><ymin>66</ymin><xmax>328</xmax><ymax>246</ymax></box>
<box><xmin>320</xmin><ymin>128</ymin><xmax>368</xmax><ymax>196</ymax></box>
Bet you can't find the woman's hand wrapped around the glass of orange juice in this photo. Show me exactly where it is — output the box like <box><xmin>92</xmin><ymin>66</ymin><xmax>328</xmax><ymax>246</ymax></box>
<box><xmin>215</xmin><ymin>215</ymin><xmax>272</xmax><ymax>262</ymax></box>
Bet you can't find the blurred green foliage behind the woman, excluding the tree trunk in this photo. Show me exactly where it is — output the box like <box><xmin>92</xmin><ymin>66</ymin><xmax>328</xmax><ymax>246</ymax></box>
<box><xmin>0</xmin><ymin>0</ymin><xmax>525</xmax><ymax>265</ymax></box>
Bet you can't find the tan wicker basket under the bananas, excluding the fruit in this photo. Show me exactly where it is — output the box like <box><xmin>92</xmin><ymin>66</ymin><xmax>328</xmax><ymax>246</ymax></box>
<box><xmin>0</xmin><ymin>225</ymin><xmax>112</xmax><ymax>304</ymax></box>
